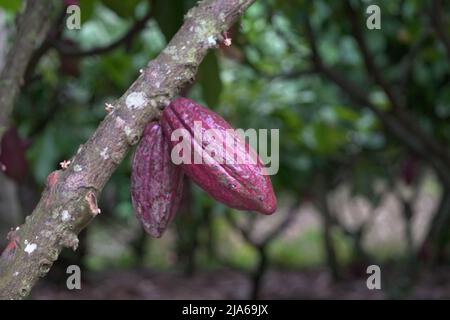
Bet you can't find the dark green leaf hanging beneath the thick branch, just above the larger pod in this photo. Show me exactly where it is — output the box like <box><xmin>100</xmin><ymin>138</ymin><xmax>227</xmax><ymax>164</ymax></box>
<box><xmin>198</xmin><ymin>51</ymin><xmax>222</xmax><ymax>109</ymax></box>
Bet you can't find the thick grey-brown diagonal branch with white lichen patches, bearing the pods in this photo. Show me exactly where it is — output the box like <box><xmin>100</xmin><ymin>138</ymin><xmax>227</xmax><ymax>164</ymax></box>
<box><xmin>0</xmin><ymin>0</ymin><xmax>254</xmax><ymax>299</ymax></box>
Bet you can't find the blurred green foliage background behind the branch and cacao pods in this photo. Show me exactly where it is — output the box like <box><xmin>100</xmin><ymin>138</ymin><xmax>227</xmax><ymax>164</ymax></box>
<box><xmin>0</xmin><ymin>0</ymin><xmax>450</xmax><ymax>298</ymax></box>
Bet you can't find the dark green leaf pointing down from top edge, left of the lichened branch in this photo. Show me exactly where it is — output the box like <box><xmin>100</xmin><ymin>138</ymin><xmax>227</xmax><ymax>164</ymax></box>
<box><xmin>153</xmin><ymin>0</ymin><xmax>184</xmax><ymax>42</ymax></box>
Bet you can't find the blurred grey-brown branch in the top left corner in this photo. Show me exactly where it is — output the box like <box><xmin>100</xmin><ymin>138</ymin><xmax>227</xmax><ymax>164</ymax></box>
<box><xmin>0</xmin><ymin>0</ymin><xmax>57</xmax><ymax>140</ymax></box>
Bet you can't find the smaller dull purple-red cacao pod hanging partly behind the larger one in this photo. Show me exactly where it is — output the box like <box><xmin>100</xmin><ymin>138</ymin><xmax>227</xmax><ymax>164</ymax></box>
<box><xmin>131</xmin><ymin>122</ymin><xmax>183</xmax><ymax>238</ymax></box>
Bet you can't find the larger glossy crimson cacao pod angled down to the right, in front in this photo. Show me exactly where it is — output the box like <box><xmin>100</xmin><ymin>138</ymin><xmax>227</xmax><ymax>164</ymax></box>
<box><xmin>161</xmin><ymin>98</ymin><xmax>277</xmax><ymax>214</ymax></box>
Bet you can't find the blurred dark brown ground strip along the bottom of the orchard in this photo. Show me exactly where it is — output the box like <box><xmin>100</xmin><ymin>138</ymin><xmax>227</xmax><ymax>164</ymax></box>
<box><xmin>32</xmin><ymin>268</ymin><xmax>450</xmax><ymax>299</ymax></box>
